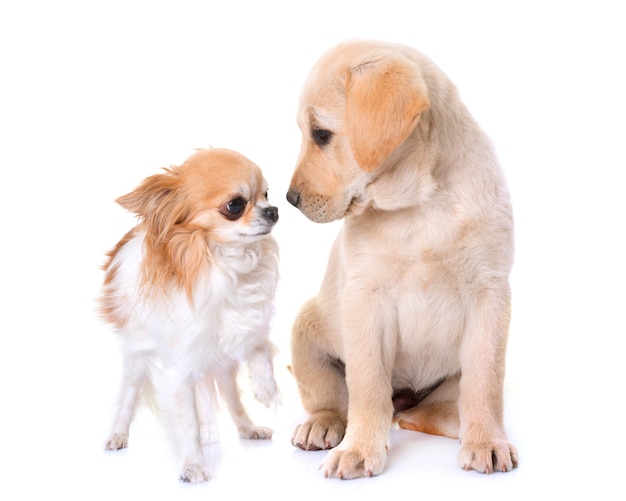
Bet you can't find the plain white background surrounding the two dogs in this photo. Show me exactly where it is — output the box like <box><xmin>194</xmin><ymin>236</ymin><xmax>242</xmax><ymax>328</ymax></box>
<box><xmin>0</xmin><ymin>0</ymin><xmax>626</xmax><ymax>499</ymax></box>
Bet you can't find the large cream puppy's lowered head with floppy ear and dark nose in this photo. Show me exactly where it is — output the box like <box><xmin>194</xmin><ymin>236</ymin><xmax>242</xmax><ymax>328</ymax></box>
<box><xmin>287</xmin><ymin>41</ymin><xmax>429</xmax><ymax>223</ymax></box>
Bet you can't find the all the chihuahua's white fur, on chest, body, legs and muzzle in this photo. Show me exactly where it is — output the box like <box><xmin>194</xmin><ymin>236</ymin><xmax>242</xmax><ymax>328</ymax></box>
<box><xmin>103</xmin><ymin>149</ymin><xmax>278</xmax><ymax>483</ymax></box>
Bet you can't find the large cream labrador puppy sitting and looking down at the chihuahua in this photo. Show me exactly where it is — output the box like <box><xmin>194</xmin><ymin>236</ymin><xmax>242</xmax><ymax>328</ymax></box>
<box><xmin>287</xmin><ymin>41</ymin><xmax>517</xmax><ymax>478</ymax></box>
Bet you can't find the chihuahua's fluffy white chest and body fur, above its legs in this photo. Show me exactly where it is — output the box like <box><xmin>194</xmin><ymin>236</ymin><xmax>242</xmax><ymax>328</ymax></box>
<box><xmin>111</xmin><ymin>232</ymin><xmax>278</xmax><ymax>370</ymax></box>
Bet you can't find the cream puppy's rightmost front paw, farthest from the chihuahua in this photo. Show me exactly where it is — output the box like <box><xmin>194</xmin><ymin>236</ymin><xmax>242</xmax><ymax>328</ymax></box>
<box><xmin>459</xmin><ymin>439</ymin><xmax>517</xmax><ymax>473</ymax></box>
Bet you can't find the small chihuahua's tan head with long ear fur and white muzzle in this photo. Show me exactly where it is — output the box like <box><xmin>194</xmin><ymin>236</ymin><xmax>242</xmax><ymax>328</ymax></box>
<box><xmin>110</xmin><ymin>145</ymin><xmax>278</xmax><ymax>297</ymax></box>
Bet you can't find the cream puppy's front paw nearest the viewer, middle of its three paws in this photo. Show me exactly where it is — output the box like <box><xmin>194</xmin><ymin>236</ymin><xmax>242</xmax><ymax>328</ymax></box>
<box><xmin>320</xmin><ymin>445</ymin><xmax>387</xmax><ymax>480</ymax></box>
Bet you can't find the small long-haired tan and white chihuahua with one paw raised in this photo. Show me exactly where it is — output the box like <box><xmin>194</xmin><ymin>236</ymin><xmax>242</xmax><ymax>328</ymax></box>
<box><xmin>99</xmin><ymin>149</ymin><xmax>278</xmax><ymax>483</ymax></box>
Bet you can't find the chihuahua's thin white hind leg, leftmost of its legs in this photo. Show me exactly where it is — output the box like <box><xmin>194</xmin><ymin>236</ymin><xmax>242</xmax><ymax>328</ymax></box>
<box><xmin>104</xmin><ymin>356</ymin><xmax>148</xmax><ymax>451</ymax></box>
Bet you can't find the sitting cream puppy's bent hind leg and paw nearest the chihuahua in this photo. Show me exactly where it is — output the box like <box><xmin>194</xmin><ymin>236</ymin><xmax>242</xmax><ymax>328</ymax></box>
<box><xmin>291</xmin><ymin>299</ymin><xmax>348</xmax><ymax>450</ymax></box>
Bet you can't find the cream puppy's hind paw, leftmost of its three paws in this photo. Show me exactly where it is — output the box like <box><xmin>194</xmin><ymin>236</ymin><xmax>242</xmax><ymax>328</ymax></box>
<box><xmin>291</xmin><ymin>411</ymin><xmax>346</xmax><ymax>451</ymax></box>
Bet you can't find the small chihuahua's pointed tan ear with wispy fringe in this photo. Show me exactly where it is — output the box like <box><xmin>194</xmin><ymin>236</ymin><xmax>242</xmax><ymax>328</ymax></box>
<box><xmin>115</xmin><ymin>168</ymin><xmax>185</xmax><ymax>235</ymax></box>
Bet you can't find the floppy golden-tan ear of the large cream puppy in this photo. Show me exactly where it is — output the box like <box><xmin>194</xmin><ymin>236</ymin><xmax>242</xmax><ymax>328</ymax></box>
<box><xmin>346</xmin><ymin>58</ymin><xmax>430</xmax><ymax>172</ymax></box>
